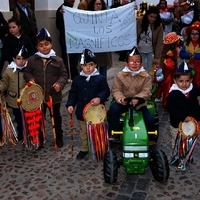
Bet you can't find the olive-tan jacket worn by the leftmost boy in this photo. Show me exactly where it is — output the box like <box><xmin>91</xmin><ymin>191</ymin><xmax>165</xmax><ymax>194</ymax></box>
<box><xmin>0</xmin><ymin>68</ymin><xmax>26</xmax><ymax>108</ymax></box>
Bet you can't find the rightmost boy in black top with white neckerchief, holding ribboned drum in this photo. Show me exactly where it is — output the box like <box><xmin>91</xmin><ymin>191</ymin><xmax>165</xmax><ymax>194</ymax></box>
<box><xmin>166</xmin><ymin>62</ymin><xmax>200</xmax><ymax>171</ymax></box>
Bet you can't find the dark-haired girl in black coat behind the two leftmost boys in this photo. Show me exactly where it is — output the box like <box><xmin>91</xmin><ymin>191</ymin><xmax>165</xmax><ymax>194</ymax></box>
<box><xmin>3</xmin><ymin>17</ymin><xmax>35</xmax><ymax>63</ymax></box>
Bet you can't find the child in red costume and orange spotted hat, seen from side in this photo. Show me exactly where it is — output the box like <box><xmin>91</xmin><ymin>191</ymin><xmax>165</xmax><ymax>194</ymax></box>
<box><xmin>156</xmin><ymin>32</ymin><xmax>180</xmax><ymax>107</ymax></box>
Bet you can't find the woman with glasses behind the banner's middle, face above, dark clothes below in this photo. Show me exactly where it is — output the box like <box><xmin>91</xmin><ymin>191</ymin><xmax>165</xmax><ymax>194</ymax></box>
<box><xmin>88</xmin><ymin>0</ymin><xmax>112</xmax><ymax>79</ymax></box>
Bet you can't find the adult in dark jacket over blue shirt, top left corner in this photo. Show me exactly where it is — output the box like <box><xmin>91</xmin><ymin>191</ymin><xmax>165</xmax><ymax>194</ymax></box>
<box><xmin>11</xmin><ymin>0</ymin><xmax>38</xmax><ymax>46</ymax></box>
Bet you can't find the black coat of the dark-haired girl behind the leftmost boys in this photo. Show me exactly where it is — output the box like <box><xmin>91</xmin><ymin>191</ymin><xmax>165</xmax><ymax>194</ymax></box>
<box><xmin>3</xmin><ymin>33</ymin><xmax>35</xmax><ymax>63</ymax></box>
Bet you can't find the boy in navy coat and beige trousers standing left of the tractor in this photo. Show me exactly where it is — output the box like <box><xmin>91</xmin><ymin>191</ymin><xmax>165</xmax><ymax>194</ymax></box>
<box><xmin>66</xmin><ymin>49</ymin><xmax>110</xmax><ymax>160</ymax></box>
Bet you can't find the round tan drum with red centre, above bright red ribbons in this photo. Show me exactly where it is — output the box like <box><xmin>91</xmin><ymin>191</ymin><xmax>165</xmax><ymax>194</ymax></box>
<box><xmin>20</xmin><ymin>83</ymin><xmax>44</xmax><ymax>112</ymax></box>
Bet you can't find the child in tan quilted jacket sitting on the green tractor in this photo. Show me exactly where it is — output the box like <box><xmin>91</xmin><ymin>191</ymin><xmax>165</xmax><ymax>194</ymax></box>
<box><xmin>110</xmin><ymin>47</ymin><xmax>155</xmax><ymax>131</ymax></box>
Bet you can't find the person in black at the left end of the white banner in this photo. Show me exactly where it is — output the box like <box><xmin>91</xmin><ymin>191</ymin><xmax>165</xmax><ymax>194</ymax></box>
<box><xmin>56</xmin><ymin>0</ymin><xmax>79</xmax><ymax>81</ymax></box>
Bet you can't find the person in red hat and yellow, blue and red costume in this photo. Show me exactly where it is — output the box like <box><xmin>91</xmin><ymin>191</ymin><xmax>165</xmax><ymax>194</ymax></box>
<box><xmin>180</xmin><ymin>21</ymin><xmax>200</xmax><ymax>86</ymax></box>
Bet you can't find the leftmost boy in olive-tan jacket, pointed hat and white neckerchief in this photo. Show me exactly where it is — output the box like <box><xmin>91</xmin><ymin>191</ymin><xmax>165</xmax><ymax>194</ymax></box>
<box><xmin>0</xmin><ymin>46</ymin><xmax>28</xmax><ymax>141</ymax></box>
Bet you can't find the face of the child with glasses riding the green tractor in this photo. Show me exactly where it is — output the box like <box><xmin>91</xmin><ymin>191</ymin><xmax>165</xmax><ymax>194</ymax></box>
<box><xmin>125</xmin><ymin>55</ymin><xmax>142</xmax><ymax>71</ymax></box>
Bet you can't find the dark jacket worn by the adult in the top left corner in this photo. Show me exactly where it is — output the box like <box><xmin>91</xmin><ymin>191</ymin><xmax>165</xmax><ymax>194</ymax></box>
<box><xmin>11</xmin><ymin>3</ymin><xmax>38</xmax><ymax>44</ymax></box>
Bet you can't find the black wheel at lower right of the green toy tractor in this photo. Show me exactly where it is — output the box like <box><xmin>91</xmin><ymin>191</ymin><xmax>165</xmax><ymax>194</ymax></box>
<box><xmin>150</xmin><ymin>145</ymin><xmax>169</xmax><ymax>182</ymax></box>
